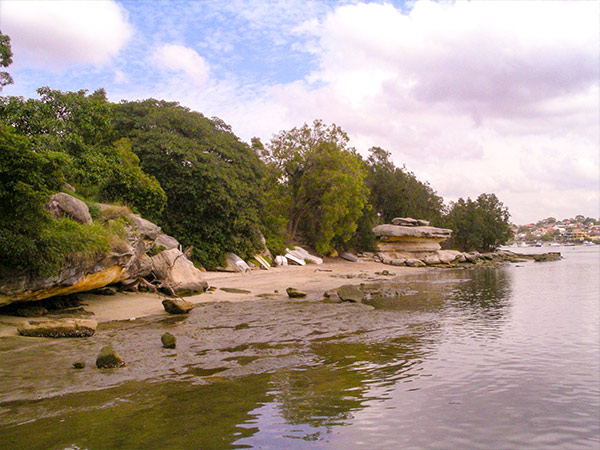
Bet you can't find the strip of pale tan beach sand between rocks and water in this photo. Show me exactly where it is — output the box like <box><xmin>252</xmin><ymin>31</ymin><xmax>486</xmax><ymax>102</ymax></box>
<box><xmin>0</xmin><ymin>259</ymin><xmax>431</xmax><ymax>336</ymax></box>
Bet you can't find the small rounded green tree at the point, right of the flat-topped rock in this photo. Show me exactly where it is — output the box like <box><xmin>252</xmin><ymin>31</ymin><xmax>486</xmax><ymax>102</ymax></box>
<box><xmin>444</xmin><ymin>194</ymin><xmax>512</xmax><ymax>251</ymax></box>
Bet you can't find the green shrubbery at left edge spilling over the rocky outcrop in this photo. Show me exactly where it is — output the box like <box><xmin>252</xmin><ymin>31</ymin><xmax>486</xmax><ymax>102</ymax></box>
<box><xmin>0</xmin><ymin>126</ymin><xmax>122</xmax><ymax>275</ymax></box>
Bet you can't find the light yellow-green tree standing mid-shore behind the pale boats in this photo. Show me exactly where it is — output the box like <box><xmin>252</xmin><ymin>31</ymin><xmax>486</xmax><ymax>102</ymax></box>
<box><xmin>262</xmin><ymin>120</ymin><xmax>368</xmax><ymax>254</ymax></box>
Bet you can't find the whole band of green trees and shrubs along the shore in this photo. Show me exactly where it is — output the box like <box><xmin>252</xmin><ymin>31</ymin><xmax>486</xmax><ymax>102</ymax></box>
<box><xmin>0</xmin><ymin>34</ymin><xmax>512</xmax><ymax>274</ymax></box>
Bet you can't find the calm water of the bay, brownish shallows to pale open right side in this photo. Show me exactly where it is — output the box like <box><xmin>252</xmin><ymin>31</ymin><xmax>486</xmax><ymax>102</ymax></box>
<box><xmin>0</xmin><ymin>247</ymin><xmax>600</xmax><ymax>449</ymax></box>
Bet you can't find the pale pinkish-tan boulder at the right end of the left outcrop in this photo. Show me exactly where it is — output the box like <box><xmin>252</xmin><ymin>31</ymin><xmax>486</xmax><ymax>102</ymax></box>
<box><xmin>151</xmin><ymin>248</ymin><xmax>208</xmax><ymax>295</ymax></box>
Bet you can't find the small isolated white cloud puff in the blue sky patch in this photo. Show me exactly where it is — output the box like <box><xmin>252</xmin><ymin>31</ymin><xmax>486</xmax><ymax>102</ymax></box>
<box><xmin>153</xmin><ymin>44</ymin><xmax>210</xmax><ymax>84</ymax></box>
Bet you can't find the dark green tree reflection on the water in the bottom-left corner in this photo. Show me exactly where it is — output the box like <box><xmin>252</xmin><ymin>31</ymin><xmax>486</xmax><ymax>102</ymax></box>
<box><xmin>0</xmin><ymin>375</ymin><xmax>268</xmax><ymax>449</ymax></box>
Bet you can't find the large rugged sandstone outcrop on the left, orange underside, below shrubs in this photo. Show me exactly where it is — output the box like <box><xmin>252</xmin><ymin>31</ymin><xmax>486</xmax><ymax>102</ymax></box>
<box><xmin>0</xmin><ymin>200</ymin><xmax>207</xmax><ymax>306</ymax></box>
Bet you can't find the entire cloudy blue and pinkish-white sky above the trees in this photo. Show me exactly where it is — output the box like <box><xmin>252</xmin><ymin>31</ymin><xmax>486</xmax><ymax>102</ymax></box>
<box><xmin>0</xmin><ymin>0</ymin><xmax>600</xmax><ymax>224</ymax></box>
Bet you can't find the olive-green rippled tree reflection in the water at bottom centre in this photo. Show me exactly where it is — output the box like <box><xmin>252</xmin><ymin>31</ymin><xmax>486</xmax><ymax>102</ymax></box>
<box><xmin>271</xmin><ymin>324</ymin><xmax>439</xmax><ymax>427</ymax></box>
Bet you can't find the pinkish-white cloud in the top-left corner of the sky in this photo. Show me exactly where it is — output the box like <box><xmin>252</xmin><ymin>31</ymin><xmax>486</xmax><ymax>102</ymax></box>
<box><xmin>0</xmin><ymin>0</ymin><xmax>132</xmax><ymax>71</ymax></box>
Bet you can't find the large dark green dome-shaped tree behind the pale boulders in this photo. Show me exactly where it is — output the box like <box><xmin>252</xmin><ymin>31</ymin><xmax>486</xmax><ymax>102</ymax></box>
<box><xmin>114</xmin><ymin>99</ymin><xmax>264</xmax><ymax>268</ymax></box>
